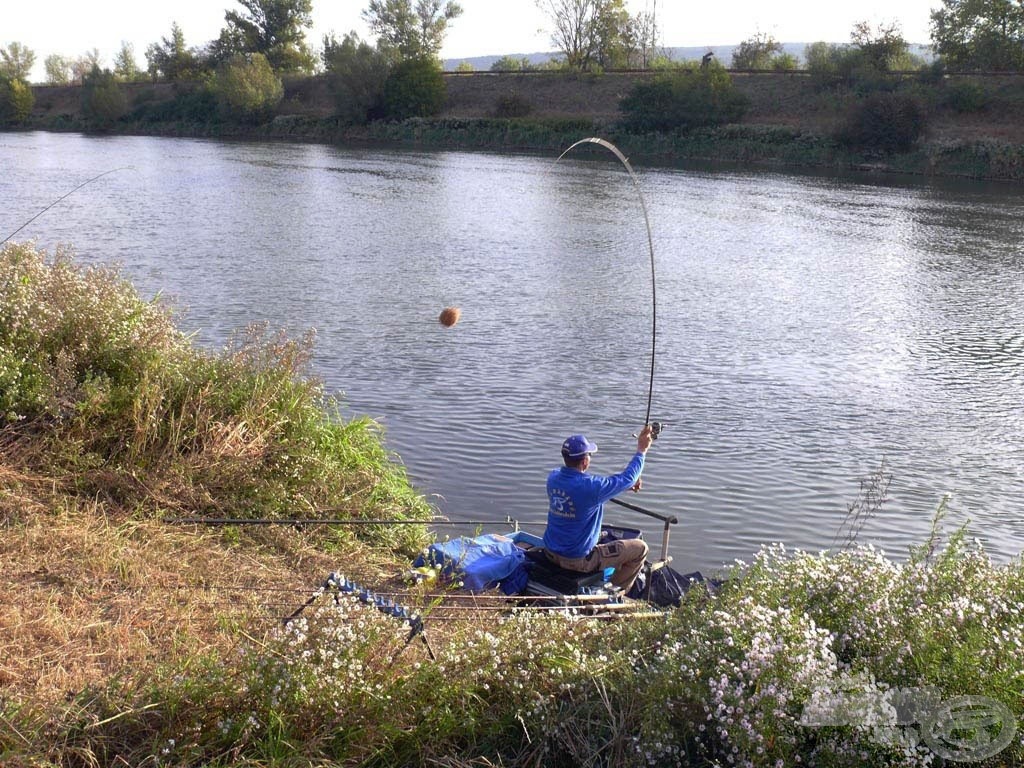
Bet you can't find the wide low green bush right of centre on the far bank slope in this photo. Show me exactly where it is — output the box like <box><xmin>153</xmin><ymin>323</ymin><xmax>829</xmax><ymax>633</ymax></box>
<box><xmin>618</xmin><ymin>66</ymin><xmax>746</xmax><ymax>133</ymax></box>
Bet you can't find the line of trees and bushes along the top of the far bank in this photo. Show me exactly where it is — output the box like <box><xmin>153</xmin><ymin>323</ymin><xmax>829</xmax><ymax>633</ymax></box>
<box><xmin>0</xmin><ymin>0</ymin><xmax>1024</xmax><ymax>146</ymax></box>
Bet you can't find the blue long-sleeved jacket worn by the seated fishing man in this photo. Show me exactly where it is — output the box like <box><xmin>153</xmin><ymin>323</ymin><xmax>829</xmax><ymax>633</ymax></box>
<box><xmin>544</xmin><ymin>453</ymin><xmax>643</xmax><ymax>557</ymax></box>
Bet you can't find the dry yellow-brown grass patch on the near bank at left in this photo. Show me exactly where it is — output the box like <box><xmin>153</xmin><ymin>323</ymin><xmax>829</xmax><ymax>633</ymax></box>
<box><xmin>0</xmin><ymin>489</ymin><xmax>397</xmax><ymax>705</ymax></box>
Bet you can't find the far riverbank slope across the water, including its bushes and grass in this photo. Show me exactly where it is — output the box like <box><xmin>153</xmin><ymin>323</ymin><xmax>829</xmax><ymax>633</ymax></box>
<box><xmin>6</xmin><ymin>61</ymin><xmax>1024</xmax><ymax>181</ymax></box>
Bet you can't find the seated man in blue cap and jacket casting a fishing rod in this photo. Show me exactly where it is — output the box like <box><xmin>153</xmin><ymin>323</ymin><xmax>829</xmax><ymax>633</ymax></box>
<box><xmin>544</xmin><ymin>425</ymin><xmax>654</xmax><ymax>592</ymax></box>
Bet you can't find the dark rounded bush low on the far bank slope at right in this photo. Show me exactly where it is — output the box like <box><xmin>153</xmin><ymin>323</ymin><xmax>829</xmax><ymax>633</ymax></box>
<box><xmin>837</xmin><ymin>93</ymin><xmax>927</xmax><ymax>153</ymax></box>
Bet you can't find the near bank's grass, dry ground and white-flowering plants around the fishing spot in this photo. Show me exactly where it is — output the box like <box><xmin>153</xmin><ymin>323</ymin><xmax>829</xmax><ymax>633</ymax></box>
<box><xmin>0</xmin><ymin>245</ymin><xmax>1024</xmax><ymax>768</ymax></box>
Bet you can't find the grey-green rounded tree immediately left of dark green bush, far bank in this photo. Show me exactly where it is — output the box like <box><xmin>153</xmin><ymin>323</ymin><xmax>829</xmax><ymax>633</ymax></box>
<box><xmin>324</xmin><ymin>32</ymin><xmax>391</xmax><ymax>125</ymax></box>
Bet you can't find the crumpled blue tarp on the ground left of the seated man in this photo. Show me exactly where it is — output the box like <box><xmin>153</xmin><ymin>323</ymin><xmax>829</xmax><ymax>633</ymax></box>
<box><xmin>414</xmin><ymin>534</ymin><xmax>527</xmax><ymax>595</ymax></box>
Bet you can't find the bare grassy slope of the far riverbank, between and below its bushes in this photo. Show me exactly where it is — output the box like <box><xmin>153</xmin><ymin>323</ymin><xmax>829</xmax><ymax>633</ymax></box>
<box><xmin>12</xmin><ymin>73</ymin><xmax>1024</xmax><ymax>182</ymax></box>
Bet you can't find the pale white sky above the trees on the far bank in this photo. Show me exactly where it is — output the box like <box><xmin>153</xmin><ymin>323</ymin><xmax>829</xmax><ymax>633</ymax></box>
<box><xmin>0</xmin><ymin>0</ymin><xmax>942</xmax><ymax>81</ymax></box>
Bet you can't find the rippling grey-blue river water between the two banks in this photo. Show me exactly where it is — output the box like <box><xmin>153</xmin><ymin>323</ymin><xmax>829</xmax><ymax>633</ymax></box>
<box><xmin>0</xmin><ymin>133</ymin><xmax>1024</xmax><ymax>570</ymax></box>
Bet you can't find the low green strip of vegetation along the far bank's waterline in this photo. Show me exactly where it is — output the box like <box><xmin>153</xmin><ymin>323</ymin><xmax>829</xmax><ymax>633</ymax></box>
<box><xmin>8</xmin><ymin>115</ymin><xmax>1024</xmax><ymax>184</ymax></box>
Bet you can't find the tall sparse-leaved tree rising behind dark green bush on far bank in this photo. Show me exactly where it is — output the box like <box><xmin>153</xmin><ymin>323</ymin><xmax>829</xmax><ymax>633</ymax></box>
<box><xmin>362</xmin><ymin>0</ymin><xmax>462</xmax><ymax>59</ymax></box>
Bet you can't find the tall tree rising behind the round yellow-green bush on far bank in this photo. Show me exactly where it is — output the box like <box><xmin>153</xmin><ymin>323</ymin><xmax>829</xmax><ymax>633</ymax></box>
<box><xmin>217</xmin><ymin>0</ymin><xmax>316</xmax><ymax>73</ymax></box>
